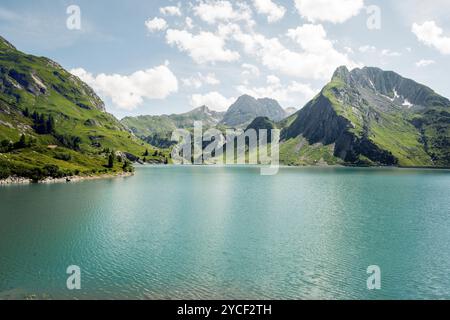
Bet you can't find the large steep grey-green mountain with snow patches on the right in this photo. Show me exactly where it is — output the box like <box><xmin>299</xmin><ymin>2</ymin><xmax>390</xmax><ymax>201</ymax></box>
<box><xmin>281</xmin><ymin>67</ymin><xmax>450</xmax><ymax>167</ymax></box>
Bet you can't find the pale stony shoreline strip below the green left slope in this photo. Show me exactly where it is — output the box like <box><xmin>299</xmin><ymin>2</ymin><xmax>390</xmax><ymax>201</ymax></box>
<box><xmin>0</xmin><ymin>172</ymin><xmax>134</xmax><ymax>186</ymax></box>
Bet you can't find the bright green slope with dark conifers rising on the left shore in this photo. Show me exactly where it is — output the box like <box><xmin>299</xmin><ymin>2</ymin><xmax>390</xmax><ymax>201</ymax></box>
<box><xmin>0</xmin><ymin>38</ymin><xmax>163</xmax><ymax>180</ymax></box>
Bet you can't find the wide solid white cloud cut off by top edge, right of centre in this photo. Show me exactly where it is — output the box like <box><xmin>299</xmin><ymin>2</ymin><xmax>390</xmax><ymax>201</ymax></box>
<box><xmin>295</xmin><ymin>0</ymin><xmax>364</xmax><ymax>23</ymax></box>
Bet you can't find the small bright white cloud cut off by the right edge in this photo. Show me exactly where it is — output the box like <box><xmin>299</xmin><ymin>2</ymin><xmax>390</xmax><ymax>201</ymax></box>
<box><xmin>412</xmin><ymin>21</ymin><xmax>450</xmax><ymax>54</ymax></box>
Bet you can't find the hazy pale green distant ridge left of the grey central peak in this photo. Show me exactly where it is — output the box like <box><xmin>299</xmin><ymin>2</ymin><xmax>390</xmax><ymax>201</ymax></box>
<box><xmin>121</xmin><ymin>106</ymin><xmax>224</xmax><ymax>148</ymax></box>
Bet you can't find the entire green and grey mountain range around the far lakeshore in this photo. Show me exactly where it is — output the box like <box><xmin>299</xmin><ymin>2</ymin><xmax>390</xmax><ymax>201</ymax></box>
<box><xmin>0</xmin><ymin>37</ymin><xmax>450</xmax><ymax>179</ymax></box>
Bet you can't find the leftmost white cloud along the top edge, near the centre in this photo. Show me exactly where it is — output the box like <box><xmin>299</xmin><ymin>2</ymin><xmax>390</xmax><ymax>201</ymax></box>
<box><xmin>193</xmin><ymin>0</ymin><xmax>255</xmax><ymax>25</ymax></box>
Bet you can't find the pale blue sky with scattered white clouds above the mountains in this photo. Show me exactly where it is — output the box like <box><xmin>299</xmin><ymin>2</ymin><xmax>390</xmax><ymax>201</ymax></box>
<box><xmin>0</xmin><ymin>0</ymin><xmax>450</xmax><ymax>118</ymax></box>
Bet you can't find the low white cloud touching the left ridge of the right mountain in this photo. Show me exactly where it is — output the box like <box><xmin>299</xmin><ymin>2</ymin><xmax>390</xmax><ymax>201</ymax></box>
<box><xmin>236</xmin><ymin>75</ymin><xmax>317</xmax><ymax>106</ymax></box>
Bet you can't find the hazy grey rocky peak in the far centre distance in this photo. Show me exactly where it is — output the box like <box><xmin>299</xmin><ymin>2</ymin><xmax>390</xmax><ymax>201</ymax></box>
<box><xmin>221</xmin><ymin>95</ymin><xmax>287</xmax><ymax>127</ymax></box>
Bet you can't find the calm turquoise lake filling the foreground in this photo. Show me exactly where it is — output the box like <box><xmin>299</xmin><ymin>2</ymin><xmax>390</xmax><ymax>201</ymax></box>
<box><xmin>0</xmin><ymin>166</ymin><xmax>450</xmax><ymax>299</ymax></box>
